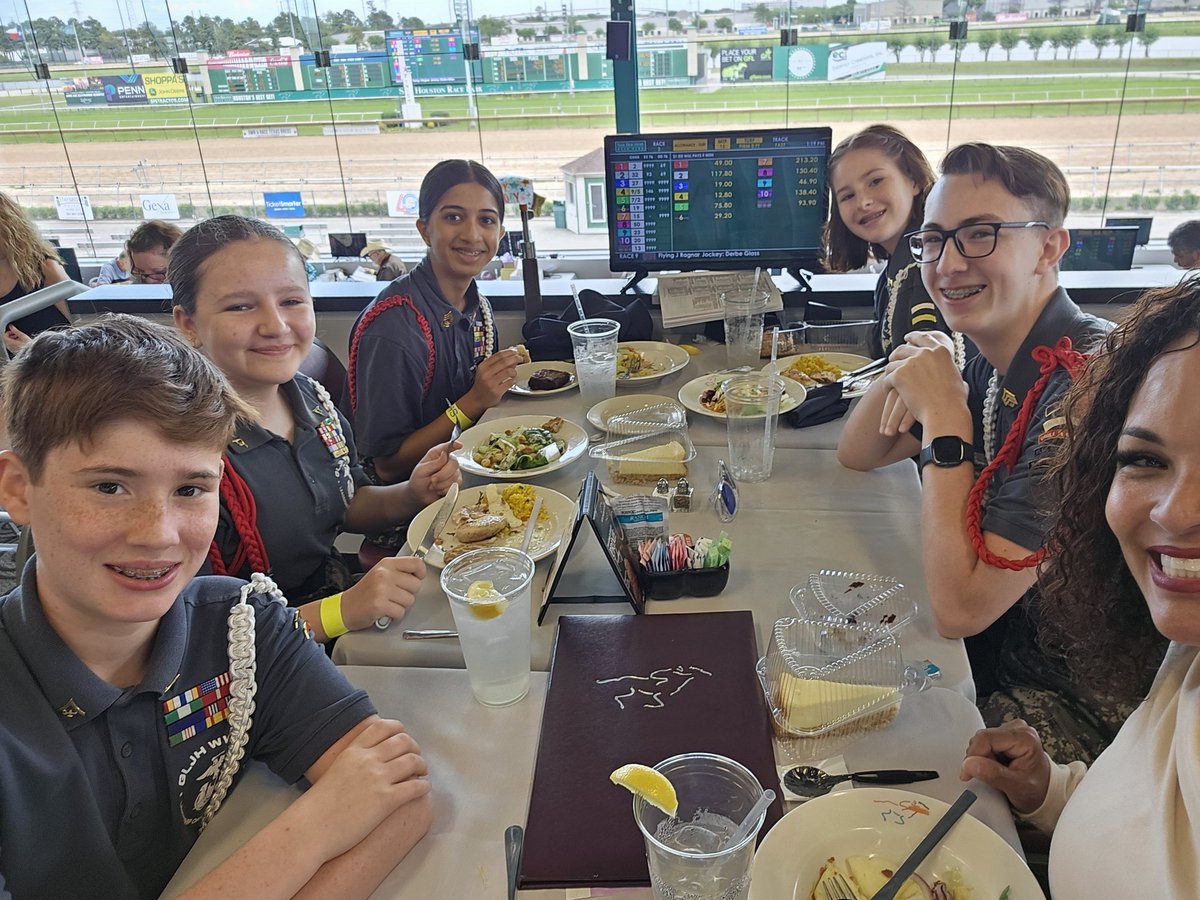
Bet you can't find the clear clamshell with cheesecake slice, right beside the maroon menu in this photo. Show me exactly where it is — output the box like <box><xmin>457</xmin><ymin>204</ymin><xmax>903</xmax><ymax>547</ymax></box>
<box><xmin>758</xmin><ymin>618</ymin><xmax>912</xmax><ymax>738</ymax></box>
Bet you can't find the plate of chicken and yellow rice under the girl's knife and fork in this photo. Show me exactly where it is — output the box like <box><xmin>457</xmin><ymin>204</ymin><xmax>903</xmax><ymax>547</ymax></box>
<box><xmin>408</xmin><ymin>482</ymin><xmax>575</xmax><ymax>569</ymax></box>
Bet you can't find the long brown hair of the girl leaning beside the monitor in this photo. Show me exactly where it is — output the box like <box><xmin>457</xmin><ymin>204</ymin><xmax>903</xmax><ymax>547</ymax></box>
<box><xmin>824</xmin><ymin>125</ymin><xmax>935</xmax><ymax>272</ymax></box>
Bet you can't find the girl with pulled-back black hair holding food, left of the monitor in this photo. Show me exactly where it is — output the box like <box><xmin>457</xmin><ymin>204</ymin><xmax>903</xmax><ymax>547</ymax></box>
<box><xmin>349</xmin><ymin>160</ymin><xmax>528</xmax><ymax>484</ymax></box>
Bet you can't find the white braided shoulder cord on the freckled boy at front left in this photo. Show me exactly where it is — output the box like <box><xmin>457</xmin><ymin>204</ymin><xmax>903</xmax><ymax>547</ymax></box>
<box><xmin>200</xmin><ymin>572</ymin><xmax>287</xmax><ymax>830</ymax></box>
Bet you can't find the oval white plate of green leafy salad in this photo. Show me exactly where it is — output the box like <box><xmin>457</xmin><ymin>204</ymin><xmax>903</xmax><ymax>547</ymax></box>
<box><xmin>454</xmin><ymin>415</ymin><xmax>588</xmax><ymax>479</ymax></box>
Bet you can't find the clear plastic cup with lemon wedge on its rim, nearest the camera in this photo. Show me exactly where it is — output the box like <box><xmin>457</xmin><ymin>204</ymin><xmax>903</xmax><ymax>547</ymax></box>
<box><xmin>634</xmin><ymin>754</ymin><xmax>767</xmax><ymax>900</ymax></box>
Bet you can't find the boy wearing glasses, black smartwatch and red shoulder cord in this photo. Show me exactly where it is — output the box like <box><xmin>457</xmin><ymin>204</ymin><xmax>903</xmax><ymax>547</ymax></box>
<box><xmin>838</xmin><ymin>144</ymin><xmax>1132</xmax><ymax>761</ymax></box>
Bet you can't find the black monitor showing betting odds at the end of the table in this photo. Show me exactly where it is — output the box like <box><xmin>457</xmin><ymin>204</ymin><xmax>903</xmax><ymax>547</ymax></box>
<box><xmin>604</xmin><ymin>127</ymin><xmax>832</xmax><ymax>272</ymax></box>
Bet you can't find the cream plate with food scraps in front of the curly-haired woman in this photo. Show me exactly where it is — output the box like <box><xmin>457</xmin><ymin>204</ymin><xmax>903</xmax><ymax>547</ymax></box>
<box><xmin>749</xmin><ymin>787</ymin><xmax>1045</xmax><ymax>900</ymax></box>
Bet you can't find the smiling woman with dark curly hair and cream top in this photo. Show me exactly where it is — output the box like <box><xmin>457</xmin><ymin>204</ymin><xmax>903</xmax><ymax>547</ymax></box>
<box><xmin>962</xmin><ymin>276</ymin><xmax>1200</xmax><ymax>900</ymax></box>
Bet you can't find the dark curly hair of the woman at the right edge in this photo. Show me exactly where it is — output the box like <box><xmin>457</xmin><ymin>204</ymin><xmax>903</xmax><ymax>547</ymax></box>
<box><xmin>1039</xmin><ymin>276</ymin><xmax>1200</xmax><ymax>697</ymax></box>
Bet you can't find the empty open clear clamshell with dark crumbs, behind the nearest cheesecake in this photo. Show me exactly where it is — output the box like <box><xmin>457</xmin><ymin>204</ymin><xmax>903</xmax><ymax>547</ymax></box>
<box><xmin>790</xmin><ymin>569</ymin><xmax>917</xmax><ymax>635</ymax></box>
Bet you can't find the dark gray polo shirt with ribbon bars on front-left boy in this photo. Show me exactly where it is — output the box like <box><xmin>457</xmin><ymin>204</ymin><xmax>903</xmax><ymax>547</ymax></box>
<box><xmin>0</xmin><ymin>557</ymin><xmax>374</xmax><ymax>899</ymax></box>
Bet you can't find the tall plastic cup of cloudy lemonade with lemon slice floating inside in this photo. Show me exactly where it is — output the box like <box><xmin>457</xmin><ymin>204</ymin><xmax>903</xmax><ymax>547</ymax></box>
<box><xmin>442</xmin><ymin>547</ymin><xmax>534</xmax><ymax>707</ymax></box>
